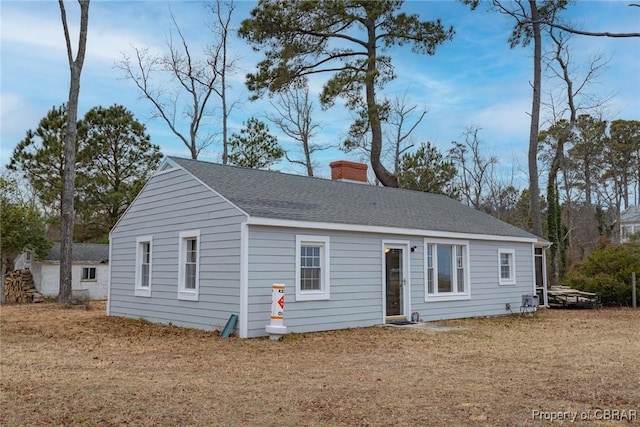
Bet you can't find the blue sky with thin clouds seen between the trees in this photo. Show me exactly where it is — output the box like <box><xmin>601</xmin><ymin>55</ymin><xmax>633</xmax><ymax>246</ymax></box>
<box><xmin>0</xmin><ymin>0</ymin><xmax>640</xmax><ymax>183</ymax></box>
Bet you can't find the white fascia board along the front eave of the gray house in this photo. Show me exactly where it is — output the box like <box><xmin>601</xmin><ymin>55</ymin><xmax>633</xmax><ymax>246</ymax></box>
<box><xmin>247</xmin><ymin>217</ymin><xmax>538</xmax><ymax>243</ymax></box>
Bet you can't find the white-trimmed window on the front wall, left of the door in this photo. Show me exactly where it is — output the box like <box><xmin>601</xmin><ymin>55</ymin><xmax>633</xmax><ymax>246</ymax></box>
<box><xmin>295</xmin><ymin>235</ymin><xmax>330</xmax><ymax>301</ymax></box>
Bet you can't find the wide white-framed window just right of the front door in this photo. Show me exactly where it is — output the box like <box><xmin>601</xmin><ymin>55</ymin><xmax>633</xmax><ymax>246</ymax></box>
<box><xmin>424</xmin><ymin>239</ymin><xmax>470</xmax><ymax>301</ymax></box>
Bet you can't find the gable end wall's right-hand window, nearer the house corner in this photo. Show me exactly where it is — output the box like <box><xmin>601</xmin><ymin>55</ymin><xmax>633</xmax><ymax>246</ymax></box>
<box><xmin>178</xmin><ymin>230</ymin><xmax>200</xmax><ymax>301</ymax></box>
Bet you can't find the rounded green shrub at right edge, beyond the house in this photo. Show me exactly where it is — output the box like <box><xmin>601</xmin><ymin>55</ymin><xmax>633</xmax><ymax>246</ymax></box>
<box><xmin>562</xmin><ymin>242</ymin><xmax>640</xmax><ymax>306</ymax></box>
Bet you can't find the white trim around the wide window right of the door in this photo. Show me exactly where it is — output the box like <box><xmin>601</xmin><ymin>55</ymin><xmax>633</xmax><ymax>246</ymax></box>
<box><xmin>422</xmin><ymin>238</ymin><xmax>471</xmax><ymax>302</ymax></box>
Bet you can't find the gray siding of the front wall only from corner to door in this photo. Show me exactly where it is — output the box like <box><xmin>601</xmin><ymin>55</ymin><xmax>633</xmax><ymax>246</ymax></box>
<box><xmin>248</xmin><ymin>226</ymin><xmax>382</xmax><ymax>337</ymax></box>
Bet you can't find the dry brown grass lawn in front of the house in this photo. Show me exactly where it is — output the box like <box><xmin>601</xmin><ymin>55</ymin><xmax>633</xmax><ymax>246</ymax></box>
<box><xmin>0</xmin><ymin>303</ymin><xmax>640</xmax><ymax>426</ymax></box>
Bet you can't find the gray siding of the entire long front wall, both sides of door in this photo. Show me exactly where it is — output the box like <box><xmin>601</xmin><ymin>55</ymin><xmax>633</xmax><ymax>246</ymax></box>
<box><xmin>248</xmin><ymin>226</ymin><xmax>533</xmax><ymax>337</ymax></box>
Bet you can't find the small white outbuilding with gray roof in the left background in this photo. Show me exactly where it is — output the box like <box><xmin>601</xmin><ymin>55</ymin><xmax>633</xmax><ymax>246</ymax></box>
<box><xmin>15</xmin><ymin>243</ymin><xmax>109</xmax><ymax>300</ymax></box>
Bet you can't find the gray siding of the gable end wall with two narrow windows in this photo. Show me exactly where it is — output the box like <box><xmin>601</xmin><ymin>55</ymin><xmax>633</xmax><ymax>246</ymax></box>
<box><xmin>109</xmin><ymin>169</ymin><xmax>246</xmax><ymax>330</ymax></box>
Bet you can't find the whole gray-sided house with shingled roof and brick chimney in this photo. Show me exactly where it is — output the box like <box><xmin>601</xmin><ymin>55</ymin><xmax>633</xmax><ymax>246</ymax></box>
<box><xmin>107</xmin><ymin>157</ymin><xmax>548</xmax><ymax>337</ymax></box>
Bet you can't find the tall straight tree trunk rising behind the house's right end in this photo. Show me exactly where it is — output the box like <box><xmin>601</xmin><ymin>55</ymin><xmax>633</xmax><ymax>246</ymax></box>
<box><xmin>529</xmin><ymin>0</ymin><xmax>542</xmax><ymax>237</ymax></box>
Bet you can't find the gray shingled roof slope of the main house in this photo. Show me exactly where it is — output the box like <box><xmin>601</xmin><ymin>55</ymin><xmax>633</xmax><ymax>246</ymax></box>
<box><xmin>168</xmin><ymin>157</ymin><xmax>544</xmax><ymax>242</ymax></box>
